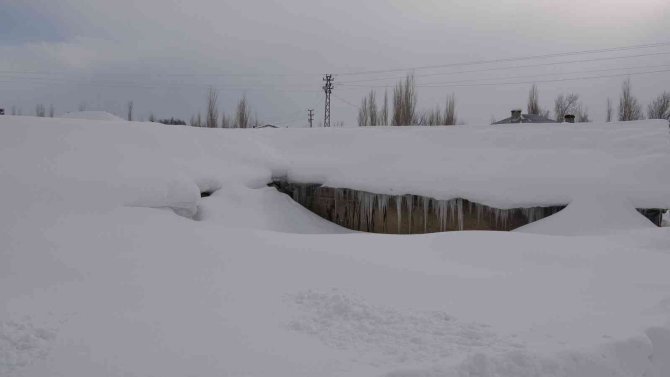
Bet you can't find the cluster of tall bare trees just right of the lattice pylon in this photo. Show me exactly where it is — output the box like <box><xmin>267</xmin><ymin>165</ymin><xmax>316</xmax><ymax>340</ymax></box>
<box><xmin>358</xmin><ymin>75</ymin><xmax>456</xmax><ymax>127</ymax></box>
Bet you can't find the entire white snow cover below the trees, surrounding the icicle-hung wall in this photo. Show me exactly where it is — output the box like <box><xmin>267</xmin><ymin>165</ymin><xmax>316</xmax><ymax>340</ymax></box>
<box><xmin>0</xmin><ymin>116</ymin><xmax>670</xmax><ymax>377</ymax></box>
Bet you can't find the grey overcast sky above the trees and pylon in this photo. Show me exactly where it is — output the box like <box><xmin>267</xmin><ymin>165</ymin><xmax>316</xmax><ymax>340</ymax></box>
<box><xmin>0</xmin><ymin>0</ymin><xmax>670</xmax><ymax>126</ymax></box>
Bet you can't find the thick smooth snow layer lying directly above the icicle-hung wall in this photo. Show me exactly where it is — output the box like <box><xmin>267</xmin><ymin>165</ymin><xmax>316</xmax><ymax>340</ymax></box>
<box><xmin>258</xmin><ymin>120</ymin><xmax>670</xmax><ymax>208</ymax></box>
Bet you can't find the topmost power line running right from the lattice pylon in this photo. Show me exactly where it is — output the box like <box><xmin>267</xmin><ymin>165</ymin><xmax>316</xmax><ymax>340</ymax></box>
<box><xmin>337</xmin><ymin>42</ymin><xmax>670</xmax><ymax>76</ymax></box>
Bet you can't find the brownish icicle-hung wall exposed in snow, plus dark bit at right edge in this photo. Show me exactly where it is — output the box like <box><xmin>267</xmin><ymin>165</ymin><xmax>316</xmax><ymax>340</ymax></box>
<box><xmin>268</xmin><ymin>178</ymin><xmax>663</xmax><ymax>234</ymax></box>
